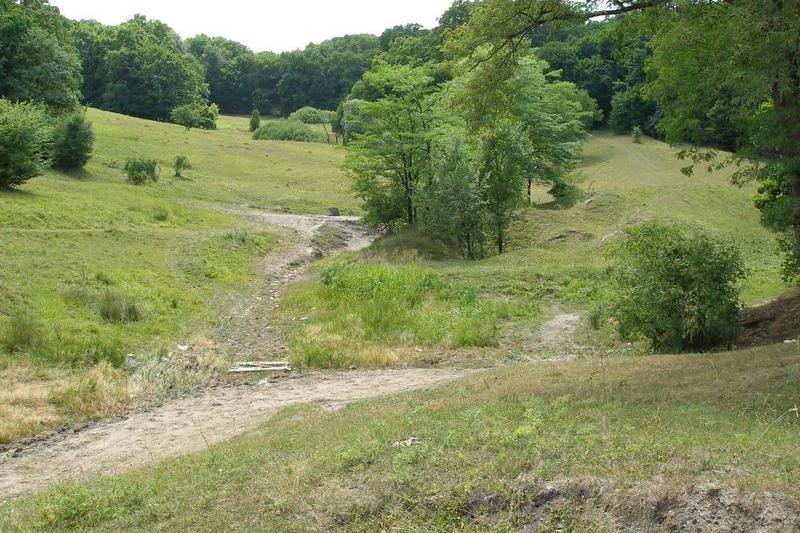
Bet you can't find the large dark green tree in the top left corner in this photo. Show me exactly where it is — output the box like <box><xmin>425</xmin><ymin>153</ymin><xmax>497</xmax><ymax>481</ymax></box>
<box><xmin>0</xmin><ymin>0</ymin><xmax>81</xmax><ymax>111</ymax></box>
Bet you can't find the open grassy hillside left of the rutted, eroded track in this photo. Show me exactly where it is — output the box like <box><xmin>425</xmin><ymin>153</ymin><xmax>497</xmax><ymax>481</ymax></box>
<box><xmin>0</xmin><ymin>109</ymin><xmax>356</xmax><ymax>442</ymax></box>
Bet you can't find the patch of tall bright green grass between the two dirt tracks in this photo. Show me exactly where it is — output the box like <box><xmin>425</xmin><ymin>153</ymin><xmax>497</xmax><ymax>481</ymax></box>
<box><xmin>285</xmin><ymin>260</ymin><xmax>511</xmax><ymax>368</ymax></box>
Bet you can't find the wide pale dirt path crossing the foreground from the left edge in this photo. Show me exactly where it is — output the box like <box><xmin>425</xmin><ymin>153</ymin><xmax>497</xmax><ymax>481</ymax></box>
<box><xmin>0</xmin><ymin>369</ymin><xmax>469</xmax><ymax>500</ymax></box>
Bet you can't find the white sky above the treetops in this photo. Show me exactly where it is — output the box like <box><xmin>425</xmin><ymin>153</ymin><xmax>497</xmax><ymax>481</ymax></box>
<box><xmin>50</xmin><ymin>0</ymin><xmax>452</xmax><ymax>52</ymax></box>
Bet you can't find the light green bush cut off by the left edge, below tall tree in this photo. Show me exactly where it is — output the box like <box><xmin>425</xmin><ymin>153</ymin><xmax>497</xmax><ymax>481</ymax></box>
<box><xmin>0</xmin><ymin>99</ymin><xmax>53</xmax><ymax>187</ymax></box>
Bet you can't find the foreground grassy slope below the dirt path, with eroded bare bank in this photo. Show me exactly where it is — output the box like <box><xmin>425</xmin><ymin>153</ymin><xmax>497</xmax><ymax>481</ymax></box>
<box><xmin>0</xmin><ymin>340</ymin><xmax>800</xmax><ymax>531</ymax></box>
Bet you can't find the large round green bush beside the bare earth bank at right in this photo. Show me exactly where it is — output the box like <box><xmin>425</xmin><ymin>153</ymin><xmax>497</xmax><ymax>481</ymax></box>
<box><xmin>607</xmin><ymin>223</ymin><xmax>745</xmax><ymax>351</ymax></box>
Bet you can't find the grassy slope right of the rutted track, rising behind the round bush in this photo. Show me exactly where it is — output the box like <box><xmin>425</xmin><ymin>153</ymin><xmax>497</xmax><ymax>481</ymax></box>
<box><xmin>285</xmin><ymin>133</ymin><xmax>788</xmax><ymax>368</ymax></box>
